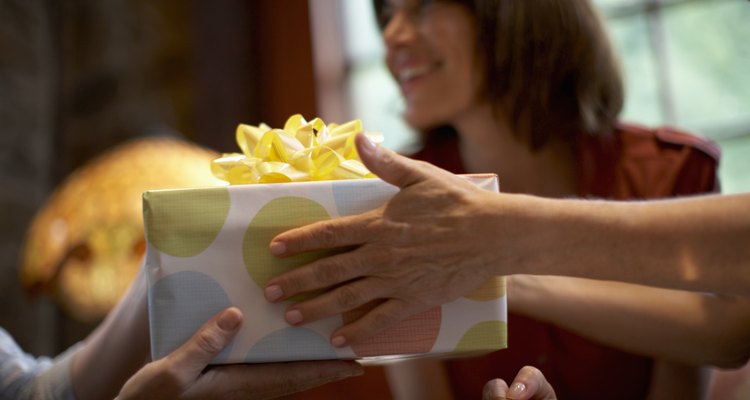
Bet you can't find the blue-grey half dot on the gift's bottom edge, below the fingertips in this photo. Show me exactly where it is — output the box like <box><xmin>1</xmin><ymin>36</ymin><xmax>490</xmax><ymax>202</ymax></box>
<box><xmin>245</xmin><ymin>327</ymin><xmax>337</xmax><ymax>363</ymax></box>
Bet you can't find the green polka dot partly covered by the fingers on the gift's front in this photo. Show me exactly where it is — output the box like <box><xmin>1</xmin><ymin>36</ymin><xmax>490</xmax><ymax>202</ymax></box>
<box><xmin>242</xmin><ymin>197</ymin><xmax>333</xmax><ymax>301</ymax></box>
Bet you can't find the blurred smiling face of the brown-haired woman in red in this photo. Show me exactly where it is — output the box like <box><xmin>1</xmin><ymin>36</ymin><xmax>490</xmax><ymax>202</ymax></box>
<box><xmin>383</xmin><ymin>2</ymin><xmax>480</xmax><ymax>129</ymax></box>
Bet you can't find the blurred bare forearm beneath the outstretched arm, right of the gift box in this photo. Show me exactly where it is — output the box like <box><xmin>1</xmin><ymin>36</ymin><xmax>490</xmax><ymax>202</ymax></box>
<box><xmin>508</xmin><ymin>275</ymin><xmax>750</xmax><ymax>368</ymax></box>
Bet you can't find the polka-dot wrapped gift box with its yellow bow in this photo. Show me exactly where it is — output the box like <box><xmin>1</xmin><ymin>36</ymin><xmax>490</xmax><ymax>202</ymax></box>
<box><xmin>143</xmin><ymin>116</ymin><xmax>507</xmax><ymax>364</ymax></box>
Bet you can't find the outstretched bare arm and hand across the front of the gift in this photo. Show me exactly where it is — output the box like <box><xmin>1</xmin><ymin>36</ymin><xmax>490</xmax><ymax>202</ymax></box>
<box><xmin>266</xmin><ymin>135</ymin><xmax>750</xmax><ymax>346</ymax></box>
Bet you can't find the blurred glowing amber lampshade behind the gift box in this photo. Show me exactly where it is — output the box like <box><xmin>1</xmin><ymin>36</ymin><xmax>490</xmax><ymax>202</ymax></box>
<box><xmin>21</xmin><ymin>137</ymin><xmax>226</xmax><ymax>322</ymax></box>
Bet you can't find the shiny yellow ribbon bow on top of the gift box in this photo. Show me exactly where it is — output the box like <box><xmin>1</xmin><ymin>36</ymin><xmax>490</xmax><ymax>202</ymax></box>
<box><xmin>211</xmin><ymin>114</ymin><xmax>383</xmax><ymax>185</ymax></box>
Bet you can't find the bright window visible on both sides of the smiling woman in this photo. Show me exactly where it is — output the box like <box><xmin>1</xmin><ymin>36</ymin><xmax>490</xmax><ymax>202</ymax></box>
<box><xmin>310</xmin><ymin>0</ymin><xmax>750</xmax><ymax>193</ymax></box>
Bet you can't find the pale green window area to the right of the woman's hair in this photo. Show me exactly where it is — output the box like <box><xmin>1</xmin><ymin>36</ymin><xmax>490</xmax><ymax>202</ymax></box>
<box><xmin>595</xmin><ymin>0</ymin><xmax>750</xmax><ymax>193</ymax></box>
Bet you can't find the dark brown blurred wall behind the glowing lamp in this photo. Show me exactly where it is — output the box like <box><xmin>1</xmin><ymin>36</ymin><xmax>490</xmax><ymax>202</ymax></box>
<box><xmin>0</xmin><ymin>0</ymin><xmax>318</xmax><ymax>355</ymax></box>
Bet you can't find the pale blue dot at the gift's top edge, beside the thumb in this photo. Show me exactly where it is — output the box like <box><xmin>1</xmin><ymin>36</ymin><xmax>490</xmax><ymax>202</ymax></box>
<box><xmin>332</xmin><ymin>179</ymin><xmax>398</xmax><ymax>215</ymax></box>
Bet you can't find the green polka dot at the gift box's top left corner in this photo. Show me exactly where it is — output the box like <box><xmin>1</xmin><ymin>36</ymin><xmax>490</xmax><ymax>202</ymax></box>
<box><xmin>143</xmin><ymin>188</ymin><xmax>230</xmax><ymax>257</ymax></box>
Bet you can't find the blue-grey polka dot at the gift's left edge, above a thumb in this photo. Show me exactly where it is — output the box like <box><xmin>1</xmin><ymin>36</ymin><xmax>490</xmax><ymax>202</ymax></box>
<box><xmin>148</xmin><ymin>271</ymin><xmax>234</xmax><ymax>364</ymax></box>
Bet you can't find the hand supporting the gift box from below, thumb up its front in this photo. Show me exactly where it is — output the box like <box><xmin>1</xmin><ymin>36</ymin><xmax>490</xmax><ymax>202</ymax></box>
<box><xmin>117</xmin><ymin>308</ymin><xmax>362</xmax><ymax>400</ymax></box>
